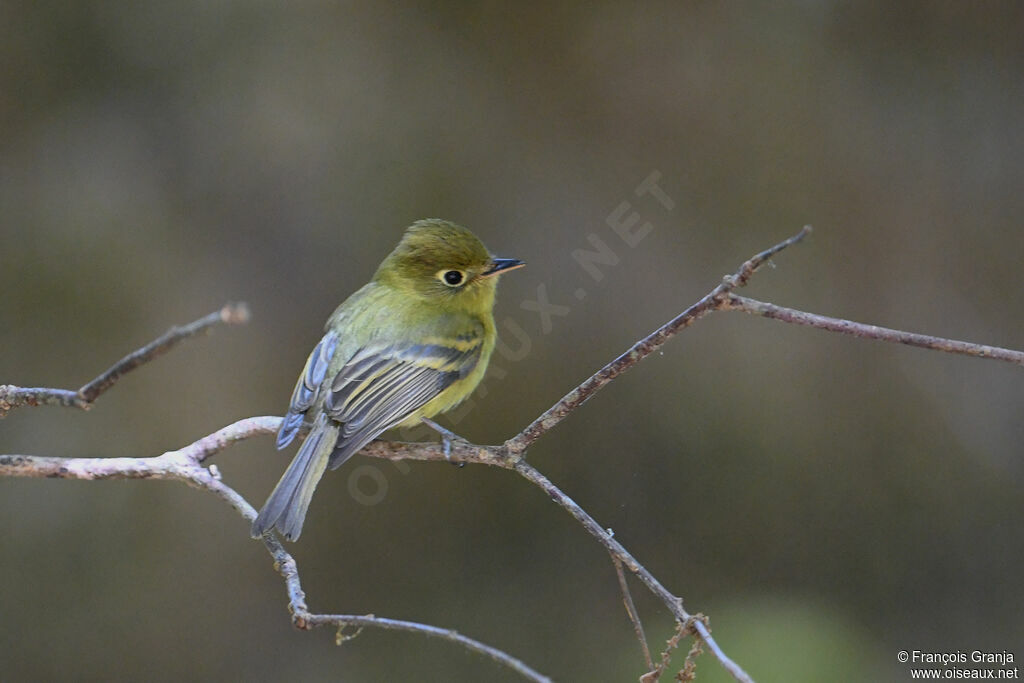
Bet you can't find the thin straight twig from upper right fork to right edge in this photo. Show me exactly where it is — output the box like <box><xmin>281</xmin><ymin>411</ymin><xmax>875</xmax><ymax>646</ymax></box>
<box><xmin>722</xmin><ymin>294</ymin><xmax>1024</xmax><ymax>366</ymax></box>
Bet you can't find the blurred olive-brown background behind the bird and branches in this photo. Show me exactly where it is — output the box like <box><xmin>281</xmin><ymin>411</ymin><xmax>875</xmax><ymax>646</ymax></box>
<box><xmin>0</xmin><ymin>0</ymin><xmax>1024</xmax><ymax>681</ymax></box>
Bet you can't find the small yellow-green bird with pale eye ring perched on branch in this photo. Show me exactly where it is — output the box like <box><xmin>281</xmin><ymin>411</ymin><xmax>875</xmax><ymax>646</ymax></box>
<box><xmin>252</xmin><ymin>219</ymin><xmax>522</xmax><ymax>541</ymax></box>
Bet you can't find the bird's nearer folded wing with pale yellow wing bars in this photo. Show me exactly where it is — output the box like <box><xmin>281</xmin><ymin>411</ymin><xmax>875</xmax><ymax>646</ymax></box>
<box><xmin>324</xmin><ymin>334</ymin><xmax>483</xmax><ymax>469</ymax></box>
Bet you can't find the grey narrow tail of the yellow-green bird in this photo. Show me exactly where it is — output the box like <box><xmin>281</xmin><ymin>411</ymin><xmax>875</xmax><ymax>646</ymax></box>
<box><xmin>252</xmin><ymin>415</ymin><xmax>339</xmax><ymax>541</ymax></box>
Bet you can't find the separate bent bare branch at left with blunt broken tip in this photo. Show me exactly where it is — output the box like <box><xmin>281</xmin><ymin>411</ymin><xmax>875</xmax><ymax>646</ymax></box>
<box><xmin>0</xmin><ymin>303</ymin><xmax>249</xmax><ymax>418</ymax></box>
